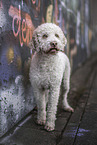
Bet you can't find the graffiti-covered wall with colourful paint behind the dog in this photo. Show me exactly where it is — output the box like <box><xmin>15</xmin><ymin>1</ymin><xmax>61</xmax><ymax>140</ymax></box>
<box><xmin>0</xmin><ymin>0</ymin><xmax>90</xmax><ymax>136</ymax></box>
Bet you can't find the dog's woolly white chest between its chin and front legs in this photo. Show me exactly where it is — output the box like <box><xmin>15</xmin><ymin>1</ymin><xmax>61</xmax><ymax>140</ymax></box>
<box><xmin>31</xmin><ymin>54</ymin><xmax>65</xmax><ymax>86</ymax></box>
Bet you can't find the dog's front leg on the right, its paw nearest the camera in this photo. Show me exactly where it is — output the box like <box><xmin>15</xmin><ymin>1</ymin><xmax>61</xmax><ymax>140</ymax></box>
<box><xmin>45</xmin><ymin>87</ymin><xmax>60</xmax><ymax>131</ymax></box>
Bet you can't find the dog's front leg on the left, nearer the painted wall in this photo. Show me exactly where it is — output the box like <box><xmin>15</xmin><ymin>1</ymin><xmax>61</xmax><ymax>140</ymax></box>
<box><xmin>34</xmin><ymin>89</ymin><xmax>46</xmax><ymax>125</ymax></box>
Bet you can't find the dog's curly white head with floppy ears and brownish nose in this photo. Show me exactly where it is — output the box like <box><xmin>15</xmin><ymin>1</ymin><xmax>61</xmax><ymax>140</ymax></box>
<box><xmin>29</xmin><ymin>23</ymin><xmax>67</xmax><ymax>54</ymax></box>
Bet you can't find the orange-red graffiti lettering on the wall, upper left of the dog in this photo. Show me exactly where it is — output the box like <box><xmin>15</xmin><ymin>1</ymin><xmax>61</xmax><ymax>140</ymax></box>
<box><xmin>9</xmin><ymin>5</ymin><xmax>34</xmax><ymax>47</ymax></box>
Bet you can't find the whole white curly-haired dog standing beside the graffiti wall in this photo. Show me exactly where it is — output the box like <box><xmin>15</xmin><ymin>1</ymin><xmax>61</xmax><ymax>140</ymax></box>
<box><xmin>29</xmin><ymin>23</ymin><xmax>73</xmax><ymax>131</ymax></box>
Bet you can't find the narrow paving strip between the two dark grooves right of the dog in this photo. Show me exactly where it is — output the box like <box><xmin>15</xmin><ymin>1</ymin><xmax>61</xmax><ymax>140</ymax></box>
<box><xmin>57</xmin><ymin>68</ymin><xmax>94</xmax><ymax>145</ymax></box>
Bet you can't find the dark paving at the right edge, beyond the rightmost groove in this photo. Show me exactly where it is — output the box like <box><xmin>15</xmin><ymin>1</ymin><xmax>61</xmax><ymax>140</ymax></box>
<box><xmin>75</xmin><ymin>68</ymin><xmax>97</xmax><ymax>145</ymax></box>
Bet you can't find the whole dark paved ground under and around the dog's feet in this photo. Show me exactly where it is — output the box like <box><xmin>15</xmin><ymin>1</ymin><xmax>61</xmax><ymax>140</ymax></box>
<box><xmin>0</xmin><ymin>54</ymin><xmax>97</xmax><ymax>145</ymax></box>
